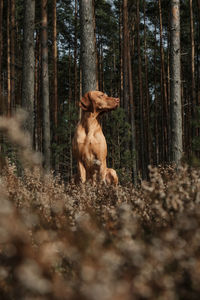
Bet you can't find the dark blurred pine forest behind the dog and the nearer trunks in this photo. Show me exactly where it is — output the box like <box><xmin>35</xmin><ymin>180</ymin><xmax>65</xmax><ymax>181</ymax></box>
<box><xmin>0</xmin><ymin>0</ymin><xmax>200</xmax><ymax>182</ymax></box>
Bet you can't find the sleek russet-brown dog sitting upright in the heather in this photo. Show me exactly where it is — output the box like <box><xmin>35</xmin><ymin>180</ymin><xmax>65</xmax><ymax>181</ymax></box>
<box><xmin>72</xmin><ymin>91</ymin><xmax>119</xmax><ymax>184</ymax></box>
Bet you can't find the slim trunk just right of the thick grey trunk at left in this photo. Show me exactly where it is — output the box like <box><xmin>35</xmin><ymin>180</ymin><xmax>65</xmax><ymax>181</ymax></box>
<box><xmin>41</xmin><ymin>0</ymin><xmax>51</xmax><ymax>172</ymax></box>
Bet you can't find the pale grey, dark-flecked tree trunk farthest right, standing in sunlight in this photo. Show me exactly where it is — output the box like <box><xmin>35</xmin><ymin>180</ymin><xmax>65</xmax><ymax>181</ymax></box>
<box><xmin>170</xmin><ymin>0</ymin><xmax>183</xmax><ymax>165</ymax></box>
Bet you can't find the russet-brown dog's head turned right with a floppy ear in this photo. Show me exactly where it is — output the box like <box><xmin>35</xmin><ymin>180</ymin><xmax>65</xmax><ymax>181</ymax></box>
<box><xmin>79</xmin><ymin>91</ymin><xmax>120</xmax><ymax>113</ymax></box>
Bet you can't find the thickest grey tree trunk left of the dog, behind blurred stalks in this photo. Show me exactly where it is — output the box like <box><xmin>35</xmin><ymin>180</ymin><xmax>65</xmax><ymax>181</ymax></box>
<box><xmin>22</xmin><ymin>0</ymin><xmax>35</xmax><ymax>140</ymax></box>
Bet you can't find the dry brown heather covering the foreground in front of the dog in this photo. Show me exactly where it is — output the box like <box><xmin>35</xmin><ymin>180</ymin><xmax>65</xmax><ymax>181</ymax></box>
<box><xmin>0</xmin><ymin>112</ymin><xmax>200</xmax><ymax>300</ymax></box>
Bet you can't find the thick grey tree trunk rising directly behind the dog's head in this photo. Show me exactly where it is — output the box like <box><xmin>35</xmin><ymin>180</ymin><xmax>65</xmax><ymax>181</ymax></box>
<box><xmin>80</xmin><ymin>0</ymin><xmax>97</xmax><ymax>94</ymax></box>
